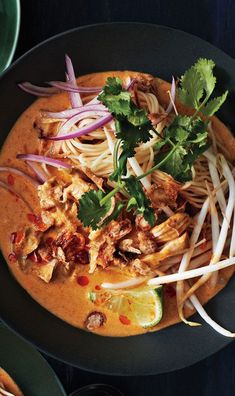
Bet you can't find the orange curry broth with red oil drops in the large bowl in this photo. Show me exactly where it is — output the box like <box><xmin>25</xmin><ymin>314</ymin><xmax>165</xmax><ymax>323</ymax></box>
<box><xmin>0</xmin><ymin>72</ymin><xmax>235</xmax><ymax>336</ymax></box>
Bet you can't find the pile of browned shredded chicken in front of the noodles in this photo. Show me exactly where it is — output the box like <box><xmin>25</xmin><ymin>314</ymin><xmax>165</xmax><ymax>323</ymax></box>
<box><xmin>14</xmin><ymin>169</ymin><xmax>190</xmax><ymax>283</ymax></box>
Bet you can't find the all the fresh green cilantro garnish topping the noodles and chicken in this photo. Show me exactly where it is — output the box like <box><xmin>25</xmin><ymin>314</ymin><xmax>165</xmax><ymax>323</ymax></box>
<box><xmin>78</xmin><ymin>59</ymin><xmax>228</xmax><ymax>229</ymax></box>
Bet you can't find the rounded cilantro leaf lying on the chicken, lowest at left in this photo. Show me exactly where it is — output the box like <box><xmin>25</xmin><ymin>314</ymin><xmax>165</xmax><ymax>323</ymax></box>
<box><xmin>78</xmin><ymin>190</ymin><xmax>111</xmax><ymax>230</ymax></box>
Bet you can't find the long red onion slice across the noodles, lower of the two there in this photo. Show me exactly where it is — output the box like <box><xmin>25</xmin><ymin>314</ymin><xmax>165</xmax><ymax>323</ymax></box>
<box><xmin>44</xmin><ymin>114</ymin><xmax>113</xmax><ymax>140</ymax></box>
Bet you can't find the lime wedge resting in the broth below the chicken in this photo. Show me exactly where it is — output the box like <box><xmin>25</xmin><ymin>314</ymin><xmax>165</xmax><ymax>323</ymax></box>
<box><xmin>88</xmin><ymin>286</ymin><xmax>163</xmax><ymax>328</ymax></box>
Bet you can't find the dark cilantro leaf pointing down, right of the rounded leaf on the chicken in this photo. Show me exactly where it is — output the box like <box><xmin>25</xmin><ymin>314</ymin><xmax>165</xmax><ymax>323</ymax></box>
<box><xmin>125</xmin><ymin>176</ymin><xmax>155</xmax><ymax>226</ymax></box>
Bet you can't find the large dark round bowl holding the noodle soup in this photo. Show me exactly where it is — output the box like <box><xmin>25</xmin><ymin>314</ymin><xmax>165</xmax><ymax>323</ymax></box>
<box><xmin>0</xmin><ymin>23</ymin><xmax>235</xmax><ymax>375</ymax></box>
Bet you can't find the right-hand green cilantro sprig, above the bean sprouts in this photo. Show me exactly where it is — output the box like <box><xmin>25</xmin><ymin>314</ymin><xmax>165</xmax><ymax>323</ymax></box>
<box><xmin>144</xmin><ymin>59</ymin><xmax>228</xmax><ymax>182</ymax></box>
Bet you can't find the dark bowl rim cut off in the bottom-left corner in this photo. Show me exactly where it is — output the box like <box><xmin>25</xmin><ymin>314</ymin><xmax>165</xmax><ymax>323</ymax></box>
<box><xmin>0</xmin><ymin>324</ymin><xmax>66</xmax><ymax>396</ymax></box>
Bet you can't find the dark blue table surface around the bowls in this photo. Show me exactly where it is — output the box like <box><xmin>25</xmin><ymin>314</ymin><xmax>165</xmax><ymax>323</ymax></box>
<box><xmin>12</xmin><ymin>0</ymin><xmax>235</xmax><ymax>396</ymax></box>
